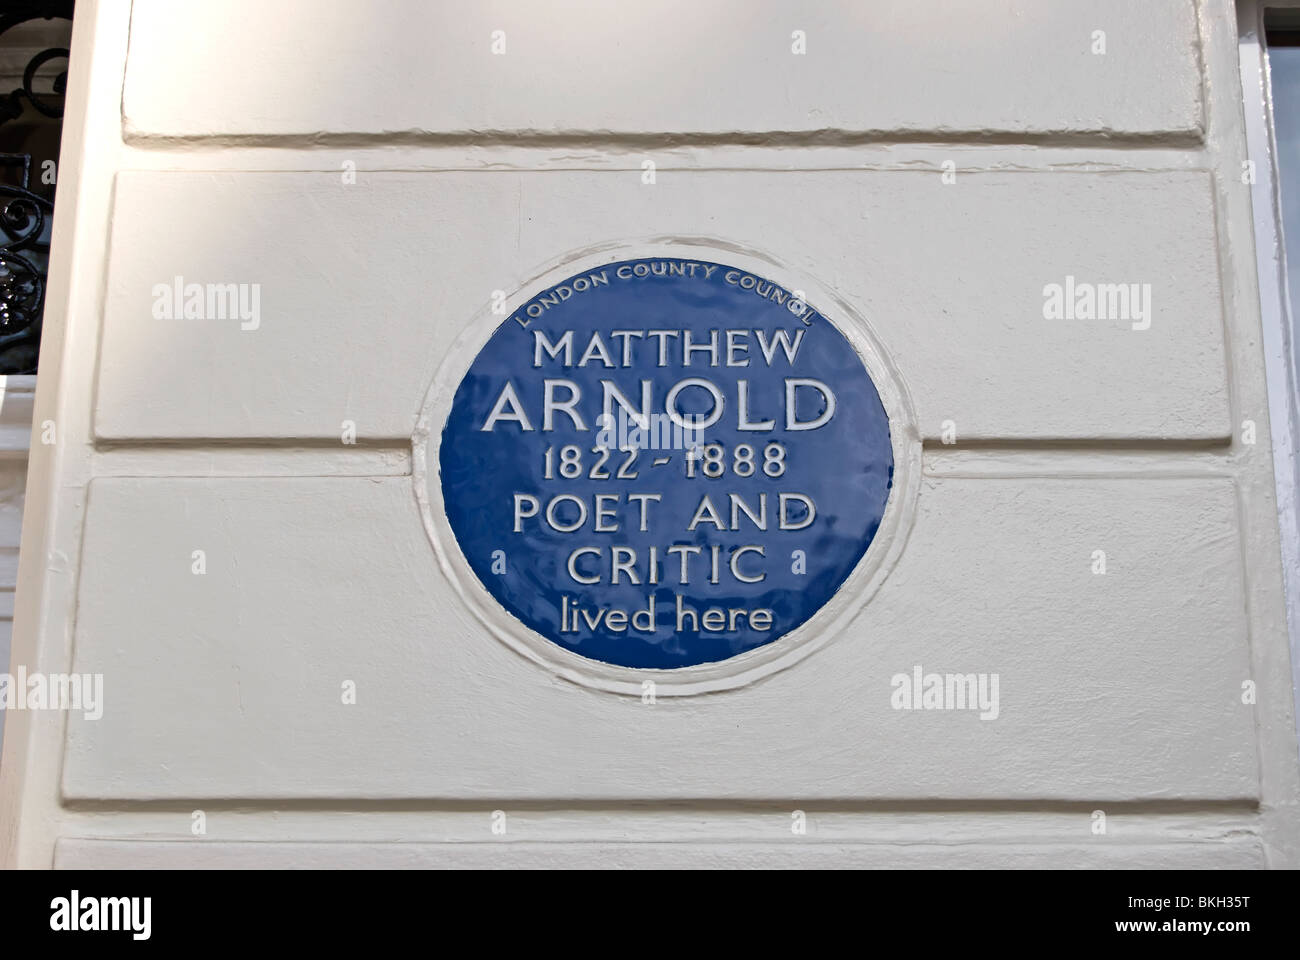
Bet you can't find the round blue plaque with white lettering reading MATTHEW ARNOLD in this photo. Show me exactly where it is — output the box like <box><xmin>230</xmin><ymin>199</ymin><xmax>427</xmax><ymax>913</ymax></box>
<box><xmin>438</xmin><ymin>258</ymin><xmax>893</xmax><ymax>670</ymax></box>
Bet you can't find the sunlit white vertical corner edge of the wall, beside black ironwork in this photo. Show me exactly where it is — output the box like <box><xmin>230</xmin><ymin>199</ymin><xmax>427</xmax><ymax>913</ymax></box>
<box><xmin>0</xmin><ymin>0</ymin><xmax>112</xmax><ymax>868</ymax></box>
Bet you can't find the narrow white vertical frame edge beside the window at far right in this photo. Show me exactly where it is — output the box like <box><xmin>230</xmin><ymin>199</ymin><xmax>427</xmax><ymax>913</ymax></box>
<box><xmin>1238</xmin><ymin>0</ymin><xmax>1300</xmax><ymax>756</ymax></box>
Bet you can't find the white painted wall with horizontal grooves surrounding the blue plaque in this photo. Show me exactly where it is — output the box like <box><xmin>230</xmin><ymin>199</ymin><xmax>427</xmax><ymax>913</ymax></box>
<box><xmin>0</xmin><ymin>0</ymin><xmax>1300</xmax><ymax>866</ymax></box>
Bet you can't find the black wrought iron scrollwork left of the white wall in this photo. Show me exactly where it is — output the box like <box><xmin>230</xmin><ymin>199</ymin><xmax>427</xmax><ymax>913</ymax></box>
<box><xmin>0</xmin><ymin>0</ymin><xmax>74</xmax><ymax>373</ymax></box>
